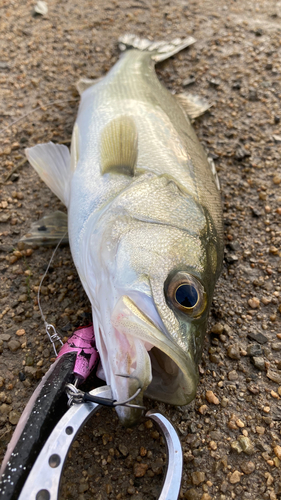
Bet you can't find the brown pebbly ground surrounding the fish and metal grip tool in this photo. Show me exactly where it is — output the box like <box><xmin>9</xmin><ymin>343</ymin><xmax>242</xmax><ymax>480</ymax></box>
<box><xmin>0</xmin><ymin>0</ymin><xmax>281</xmax><ymax>500</ymax></box>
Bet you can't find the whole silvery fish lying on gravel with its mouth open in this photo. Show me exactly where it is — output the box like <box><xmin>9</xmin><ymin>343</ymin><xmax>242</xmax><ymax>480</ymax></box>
<box><xmin>22</xmin><ymin>34</ymin><xmax>223</xmax><ymax>425</ymax></box>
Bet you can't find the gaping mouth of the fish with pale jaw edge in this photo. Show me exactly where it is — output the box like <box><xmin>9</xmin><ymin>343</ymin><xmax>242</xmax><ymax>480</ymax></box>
<box><xmin>111</xmin><ymin>295</ymin><xmax>198</xmax><ymax>420</ymax></box>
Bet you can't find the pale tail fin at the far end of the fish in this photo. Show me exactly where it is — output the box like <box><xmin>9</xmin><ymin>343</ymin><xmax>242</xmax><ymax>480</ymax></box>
<box><xmin>119</xmin><ymin>33</ymin><xmax>196</xmax><ymax>62</ymax></box>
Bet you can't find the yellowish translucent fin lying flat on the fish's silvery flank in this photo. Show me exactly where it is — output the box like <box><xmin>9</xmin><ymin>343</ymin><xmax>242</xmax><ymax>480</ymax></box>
<box><xmin>101</xmin><ymin>115</ymin><xmax>138</xmax><ymax>176</ymax></box>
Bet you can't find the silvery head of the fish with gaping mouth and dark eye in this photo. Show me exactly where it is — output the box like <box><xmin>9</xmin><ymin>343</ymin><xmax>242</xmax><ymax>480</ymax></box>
<box><xmin>91</xmin><ymin>204</ymin><xmax>222</xmax><ymax>424</ymax></box>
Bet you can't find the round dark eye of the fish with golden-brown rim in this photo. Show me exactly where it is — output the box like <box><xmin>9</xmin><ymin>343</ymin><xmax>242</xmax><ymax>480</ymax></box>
<box><xmin>165</xmin><ymin>272</ymin><xmax>207</xmax><ymax>317</ymax></box>
